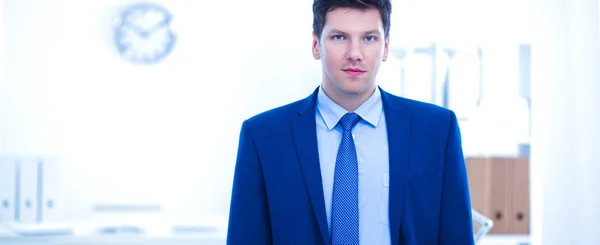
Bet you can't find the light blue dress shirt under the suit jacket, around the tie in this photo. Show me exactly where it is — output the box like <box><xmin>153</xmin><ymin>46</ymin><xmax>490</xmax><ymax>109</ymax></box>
<box><xmin>316</xmin><ymin>87</ymin><xmax>391</xmax><ymax>245</ymax></box>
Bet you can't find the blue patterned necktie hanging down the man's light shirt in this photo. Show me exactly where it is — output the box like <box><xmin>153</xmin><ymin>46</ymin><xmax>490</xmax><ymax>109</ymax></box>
<box><xmin>331</xmin><ymin>113</ymin><xmax>360</xmax><ymax>245</ymax></box>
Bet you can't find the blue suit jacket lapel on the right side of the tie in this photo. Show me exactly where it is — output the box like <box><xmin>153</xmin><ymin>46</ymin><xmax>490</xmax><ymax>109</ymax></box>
<box><xmin>381</xmin><ymin>87</ymin><xmax>410</xmax><ymax>244</ymax></box>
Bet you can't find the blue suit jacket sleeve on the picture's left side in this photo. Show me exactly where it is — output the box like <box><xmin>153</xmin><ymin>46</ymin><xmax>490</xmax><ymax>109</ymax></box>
<box><xmin>227</xmin><ymin>121</ymin><xmax>271</xmax><ymax>245</ymax></box>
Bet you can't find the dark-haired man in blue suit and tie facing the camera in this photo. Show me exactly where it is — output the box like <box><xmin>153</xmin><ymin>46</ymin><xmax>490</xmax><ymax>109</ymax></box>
<box><xmin>227</xmin><ymin>0</ymin><xmax>473</xmax><ymax>245</ymax></box>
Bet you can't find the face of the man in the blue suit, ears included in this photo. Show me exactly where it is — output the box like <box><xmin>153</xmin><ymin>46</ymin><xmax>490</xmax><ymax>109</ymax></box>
<box><xmin>312</xmin><ymin>8</ymin><xmax>389</xmax><ymax>96</ymax></box>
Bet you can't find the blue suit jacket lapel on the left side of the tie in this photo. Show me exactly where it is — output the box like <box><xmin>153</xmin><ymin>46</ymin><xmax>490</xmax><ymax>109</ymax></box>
<box><xmin>292</xmin><ymin>87</ymin><xmax>329</xmax><ymax>244</ymax></box>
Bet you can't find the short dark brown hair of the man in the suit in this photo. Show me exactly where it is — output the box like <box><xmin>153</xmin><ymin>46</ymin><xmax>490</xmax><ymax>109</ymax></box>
<box><xmin>313</xmin><ymin>0</ymin><xmax>392</xmax><ymax>39</ymax></box>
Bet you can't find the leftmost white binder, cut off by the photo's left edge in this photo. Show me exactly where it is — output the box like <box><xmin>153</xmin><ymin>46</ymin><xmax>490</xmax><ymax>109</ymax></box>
<box><xmin>0</xmin><ymin>158</ymin><xmax>17</xmax><ymax>224</ymax></box>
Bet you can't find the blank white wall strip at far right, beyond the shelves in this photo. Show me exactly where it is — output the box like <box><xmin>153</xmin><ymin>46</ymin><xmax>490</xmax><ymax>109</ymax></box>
<box><xmin>531</xmin><ymin>0</ymin><xmax>600</xmax><ymax>245</ymax></box>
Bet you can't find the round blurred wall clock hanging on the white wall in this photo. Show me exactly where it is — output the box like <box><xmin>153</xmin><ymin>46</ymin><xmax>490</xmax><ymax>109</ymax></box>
<box><xmin>115</xmin><ymin>3</ymin><xmax>176</xmax><ymax>64</ymax></box>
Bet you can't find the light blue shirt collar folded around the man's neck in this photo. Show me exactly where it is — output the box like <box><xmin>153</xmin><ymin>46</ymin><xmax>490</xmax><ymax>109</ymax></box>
<box><xmin>317</xmin><ymin>86</ymin><xmax>383</xmax><ymax>130</ymax></box>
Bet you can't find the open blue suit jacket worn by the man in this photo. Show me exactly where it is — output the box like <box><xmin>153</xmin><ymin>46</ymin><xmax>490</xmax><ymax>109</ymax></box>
<box><xmin>227</xmin><ymin>87</ymin><xmax>473</xmax><ymax>245</ymax></box>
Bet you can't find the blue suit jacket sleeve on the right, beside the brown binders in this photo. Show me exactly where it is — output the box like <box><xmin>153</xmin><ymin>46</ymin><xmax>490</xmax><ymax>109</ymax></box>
<box><xmin>439</xmin><ymin>112</ymin><xmax>474</xmax><ymax>245</ymax></box>
